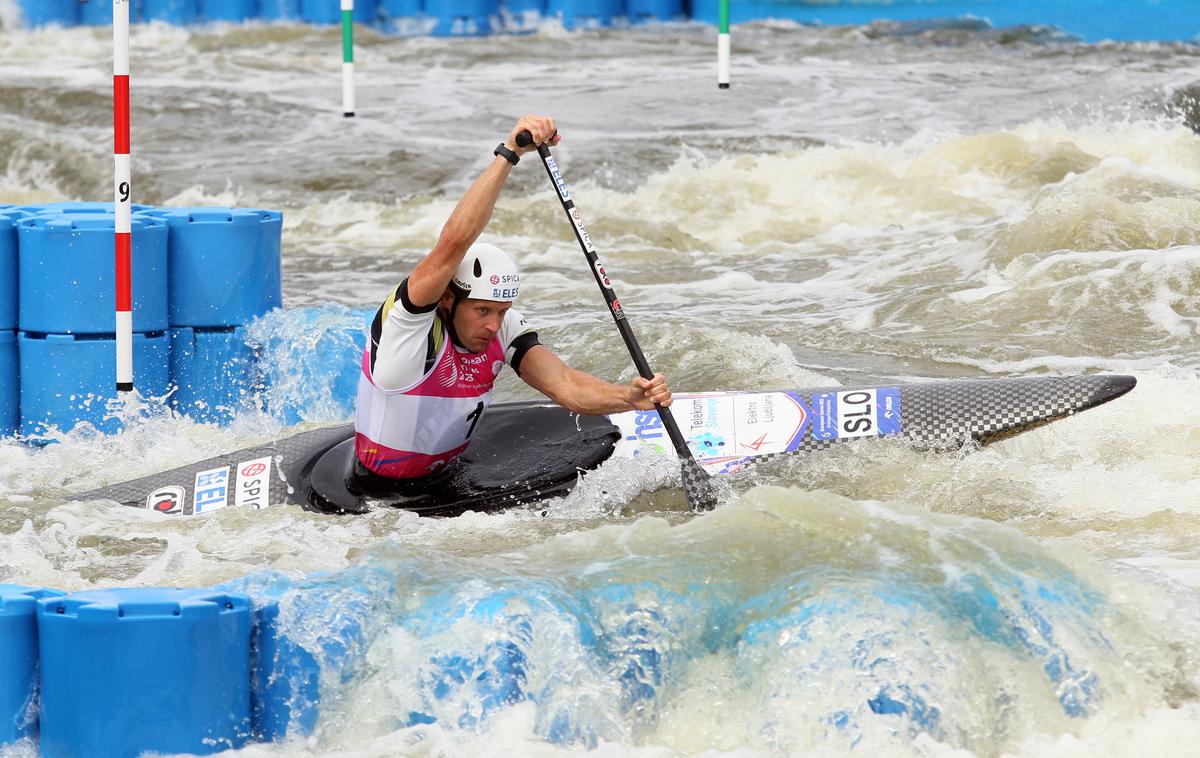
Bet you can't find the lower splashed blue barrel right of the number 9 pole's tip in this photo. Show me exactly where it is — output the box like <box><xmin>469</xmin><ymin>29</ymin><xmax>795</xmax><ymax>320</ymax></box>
<box><xmin>170</xmin><ymin>326</ymin><xmax>262</xmax><ymax>423</ymax></box>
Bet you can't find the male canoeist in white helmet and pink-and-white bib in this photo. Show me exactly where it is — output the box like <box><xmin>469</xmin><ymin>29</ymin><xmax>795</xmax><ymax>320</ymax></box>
<box><xmin>354</xmin><ymin>115</ymin><xmax>671</xmax><ymax>491</ymax></box>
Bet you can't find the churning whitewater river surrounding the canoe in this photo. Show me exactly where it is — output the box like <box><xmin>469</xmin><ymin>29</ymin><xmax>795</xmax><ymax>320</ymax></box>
<box><xmin>0</xmin><ymin>17</ymin><xmax>1200</xmax><ymax>757</ymax></box>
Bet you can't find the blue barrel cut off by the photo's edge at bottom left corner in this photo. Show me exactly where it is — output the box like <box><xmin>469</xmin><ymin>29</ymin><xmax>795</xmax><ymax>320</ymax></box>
<box><xmin>0</xmin><ymin>584</ymin><xmax>62</xmax><ymax>747</ymax></box>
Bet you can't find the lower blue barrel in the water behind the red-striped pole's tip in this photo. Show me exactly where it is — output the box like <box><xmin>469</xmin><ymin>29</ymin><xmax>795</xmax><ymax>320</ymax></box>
<box><xmin>17</xmin><ymin>332</ymin><xmax>170</xmax><ymax>437</ymax></box>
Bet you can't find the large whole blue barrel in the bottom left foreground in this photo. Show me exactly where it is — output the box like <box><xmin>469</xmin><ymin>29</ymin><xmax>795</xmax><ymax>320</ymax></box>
<box><xmin>37</xmin><ymin>588</ymin><xmax>251</xmax><ymax>758</ymax></box>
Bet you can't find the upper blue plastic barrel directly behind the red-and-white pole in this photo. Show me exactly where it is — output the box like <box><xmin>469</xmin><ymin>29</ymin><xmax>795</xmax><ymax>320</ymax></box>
<box><xmin>17</xmin><ymin>213</ymin><xmax>168</xmax><ymax>335</ymax></box>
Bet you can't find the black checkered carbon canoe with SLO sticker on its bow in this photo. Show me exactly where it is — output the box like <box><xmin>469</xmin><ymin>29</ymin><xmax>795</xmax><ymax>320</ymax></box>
<box><xmin>74</xmin><ymin>375</ymin><xmax>1136</xmax><ymax>516</ymax></box>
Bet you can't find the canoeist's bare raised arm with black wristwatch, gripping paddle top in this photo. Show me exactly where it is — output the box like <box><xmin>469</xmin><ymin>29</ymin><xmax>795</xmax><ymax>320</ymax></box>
<box><xmin>408</xmin><ymin>115</ymin><xmax>558</xmax><ymax>307</ymax></box>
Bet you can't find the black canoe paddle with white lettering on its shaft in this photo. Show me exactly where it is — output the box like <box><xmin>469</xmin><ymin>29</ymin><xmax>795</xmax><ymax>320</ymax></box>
<box><xmin>517</xmin><ymin>131</ymin><xmax>716</xmax><ymax>511</ymax></box>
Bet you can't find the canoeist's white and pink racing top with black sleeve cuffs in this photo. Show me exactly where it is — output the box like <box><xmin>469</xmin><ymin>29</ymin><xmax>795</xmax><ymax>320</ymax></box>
<box><xmin>354</xmin><ymin>278</ymin><xmax>539</xmax><ymax>479</ymax></box>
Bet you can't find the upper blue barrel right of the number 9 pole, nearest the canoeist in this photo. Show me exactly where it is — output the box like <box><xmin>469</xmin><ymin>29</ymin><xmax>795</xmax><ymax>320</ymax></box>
<box><xmin>138</xmin><ymin>207</ymin><xmax>283</xmax><ymax>326</ymax></box>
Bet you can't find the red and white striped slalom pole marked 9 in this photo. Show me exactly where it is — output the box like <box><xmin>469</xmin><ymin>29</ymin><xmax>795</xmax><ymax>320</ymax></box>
<box><xmin>113</xmin><ymin>0</ymin><xmax>133</xmax><ymax>392</ymax></box>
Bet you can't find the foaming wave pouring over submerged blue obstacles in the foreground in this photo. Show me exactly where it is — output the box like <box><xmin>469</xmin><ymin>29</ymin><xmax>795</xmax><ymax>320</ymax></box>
<box><xmin>204</xmin><ymin>487</ymin><xmax>1200</xmax><ymax>756</ymax></box>
